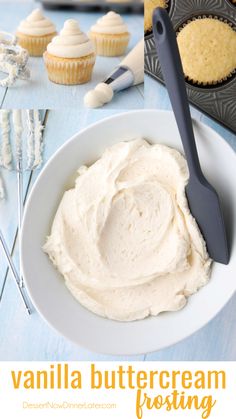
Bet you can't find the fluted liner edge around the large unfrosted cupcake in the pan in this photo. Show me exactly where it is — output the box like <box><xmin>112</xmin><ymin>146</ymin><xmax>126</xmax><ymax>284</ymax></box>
<box><xmin>176</xmin><ymin>15</ymin><xmax>236</xmax><ymax>87</ymax></box>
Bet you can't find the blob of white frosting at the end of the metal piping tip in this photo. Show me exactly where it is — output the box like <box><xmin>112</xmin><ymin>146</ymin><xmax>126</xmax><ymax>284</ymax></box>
<box><xmin>84</xmin><ymin>83</ymin><xmax>114</xmax><ymax>108</ymax></box>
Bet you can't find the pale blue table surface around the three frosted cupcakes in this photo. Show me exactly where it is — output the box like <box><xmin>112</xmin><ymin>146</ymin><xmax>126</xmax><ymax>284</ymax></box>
<box><xmin>0</xmin><ymin>0</ymin><xmax>143</xmax><ymax>109</ymax></box>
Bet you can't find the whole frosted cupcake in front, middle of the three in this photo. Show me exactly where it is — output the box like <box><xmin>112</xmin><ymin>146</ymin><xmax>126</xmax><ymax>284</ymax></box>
<box><xmin>44</xmin><ymin>19</ymin><xmax>95</xmax><ymax>84</ymax></box>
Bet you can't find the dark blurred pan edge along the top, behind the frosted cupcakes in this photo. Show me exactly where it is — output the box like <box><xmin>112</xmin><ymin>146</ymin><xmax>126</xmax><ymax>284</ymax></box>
<box><xmin>39</xmin><ymin>0</ymin><xmax>144</xmax><ymax>13</ymax></box>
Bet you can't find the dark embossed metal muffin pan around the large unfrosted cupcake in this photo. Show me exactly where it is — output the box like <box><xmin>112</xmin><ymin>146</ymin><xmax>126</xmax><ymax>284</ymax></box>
<box><xmin>145</xmin><ymin>0</ymin><xmax>236</xmax><ymax>133</ymax></box>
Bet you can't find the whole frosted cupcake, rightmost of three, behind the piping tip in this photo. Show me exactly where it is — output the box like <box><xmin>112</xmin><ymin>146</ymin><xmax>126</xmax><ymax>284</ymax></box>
<box><xmin>89</xmin><ymin>12</ymin><xmax>130</xmax><ymax>57</ymax></box>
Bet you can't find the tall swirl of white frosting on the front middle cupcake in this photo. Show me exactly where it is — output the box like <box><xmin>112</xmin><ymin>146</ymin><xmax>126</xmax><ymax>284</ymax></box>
<box><xmin>47</xmin><ymin>19</ymin><xmax>94</xmax><ymax>58</ymax></box>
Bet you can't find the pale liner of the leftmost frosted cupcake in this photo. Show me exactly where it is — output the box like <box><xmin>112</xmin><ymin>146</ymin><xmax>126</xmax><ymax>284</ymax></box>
<box><xmin>16</xmin><ymin>32</ymin><xmax>56</xmax><ymax>57</ymax></box>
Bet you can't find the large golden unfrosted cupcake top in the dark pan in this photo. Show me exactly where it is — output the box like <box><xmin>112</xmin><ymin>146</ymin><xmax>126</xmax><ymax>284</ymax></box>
<box><xmin>177</xmin><ymin>17</ymin><xmax>236</xmax><ymax>85</ymax></box>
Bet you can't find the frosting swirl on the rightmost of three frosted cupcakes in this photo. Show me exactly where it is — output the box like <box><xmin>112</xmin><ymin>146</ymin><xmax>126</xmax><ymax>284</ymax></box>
<box><xmin>91</xmin><ymin>12</ymin><xmax>129</xmax><ymax>34</ymax></box>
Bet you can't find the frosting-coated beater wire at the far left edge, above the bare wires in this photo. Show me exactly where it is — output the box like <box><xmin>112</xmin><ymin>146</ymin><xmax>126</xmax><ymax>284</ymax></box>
<box><xmin>0</xmin><ymin>109</ymin><xmax>12</xmax><ymax>170</ymax></box>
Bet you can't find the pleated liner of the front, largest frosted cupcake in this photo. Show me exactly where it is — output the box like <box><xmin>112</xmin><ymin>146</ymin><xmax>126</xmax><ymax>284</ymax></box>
<box><xmin>43</xmin><ymin>51</ymin><xmax>95</xmax><ymax>85</ymax></box>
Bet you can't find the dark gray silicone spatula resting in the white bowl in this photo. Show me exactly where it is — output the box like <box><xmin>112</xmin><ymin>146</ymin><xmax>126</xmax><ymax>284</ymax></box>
<box><xmin>153</xmin><ymin>8</ymin><xmax>229</xmax><ymax>264</ymax></box>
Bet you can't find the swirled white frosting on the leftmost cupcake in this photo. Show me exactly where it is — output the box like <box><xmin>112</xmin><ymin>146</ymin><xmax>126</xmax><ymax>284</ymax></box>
<box><xmin>17</xmin><ymin>9</ymin><xmax>56</xmax><ymax>36</ymax></box>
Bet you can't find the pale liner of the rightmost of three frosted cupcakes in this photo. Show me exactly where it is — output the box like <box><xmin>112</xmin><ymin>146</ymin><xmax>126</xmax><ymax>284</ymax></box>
<box><xmin>89</xmin><ymin>32</ymin><xmax>130</xmax><ymax>57</ymax></box>
